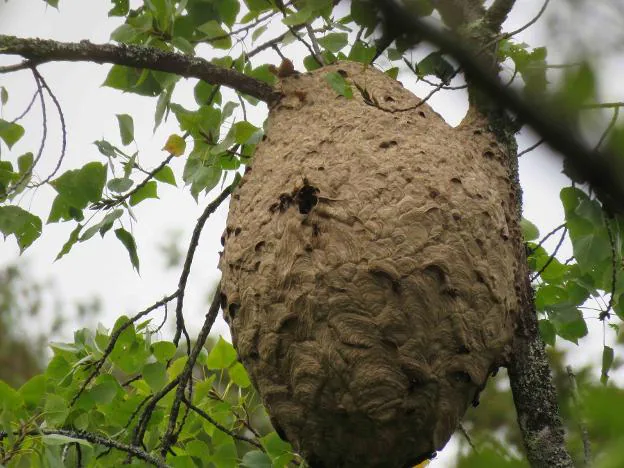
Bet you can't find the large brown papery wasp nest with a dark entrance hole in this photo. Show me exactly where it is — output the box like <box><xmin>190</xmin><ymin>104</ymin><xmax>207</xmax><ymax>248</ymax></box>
<box><xmin>220</xmin><ymin>62</ymin><xmax>518</xmax><ymax>468</ymax></box>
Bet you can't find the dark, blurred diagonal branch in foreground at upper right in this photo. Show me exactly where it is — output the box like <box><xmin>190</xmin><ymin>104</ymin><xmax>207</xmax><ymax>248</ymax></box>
<box><xmin>384</xmin><ymin>0</ymin><xmax>624</xmax><ymax>213</ymax></box>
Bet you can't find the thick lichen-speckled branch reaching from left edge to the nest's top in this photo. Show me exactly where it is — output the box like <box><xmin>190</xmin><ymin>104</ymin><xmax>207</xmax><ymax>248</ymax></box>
<box><xmin>0</xmin><ymin>35</ymin><xmax>280</xmax><ymax>104</ymax></box>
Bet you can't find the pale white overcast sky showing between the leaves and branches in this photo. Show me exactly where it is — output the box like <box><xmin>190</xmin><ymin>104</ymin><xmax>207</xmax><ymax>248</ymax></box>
<box><xmin>0</xmin><ymin>0</ymin><xmax>624</xmax><ymax>466</ymax></box>
